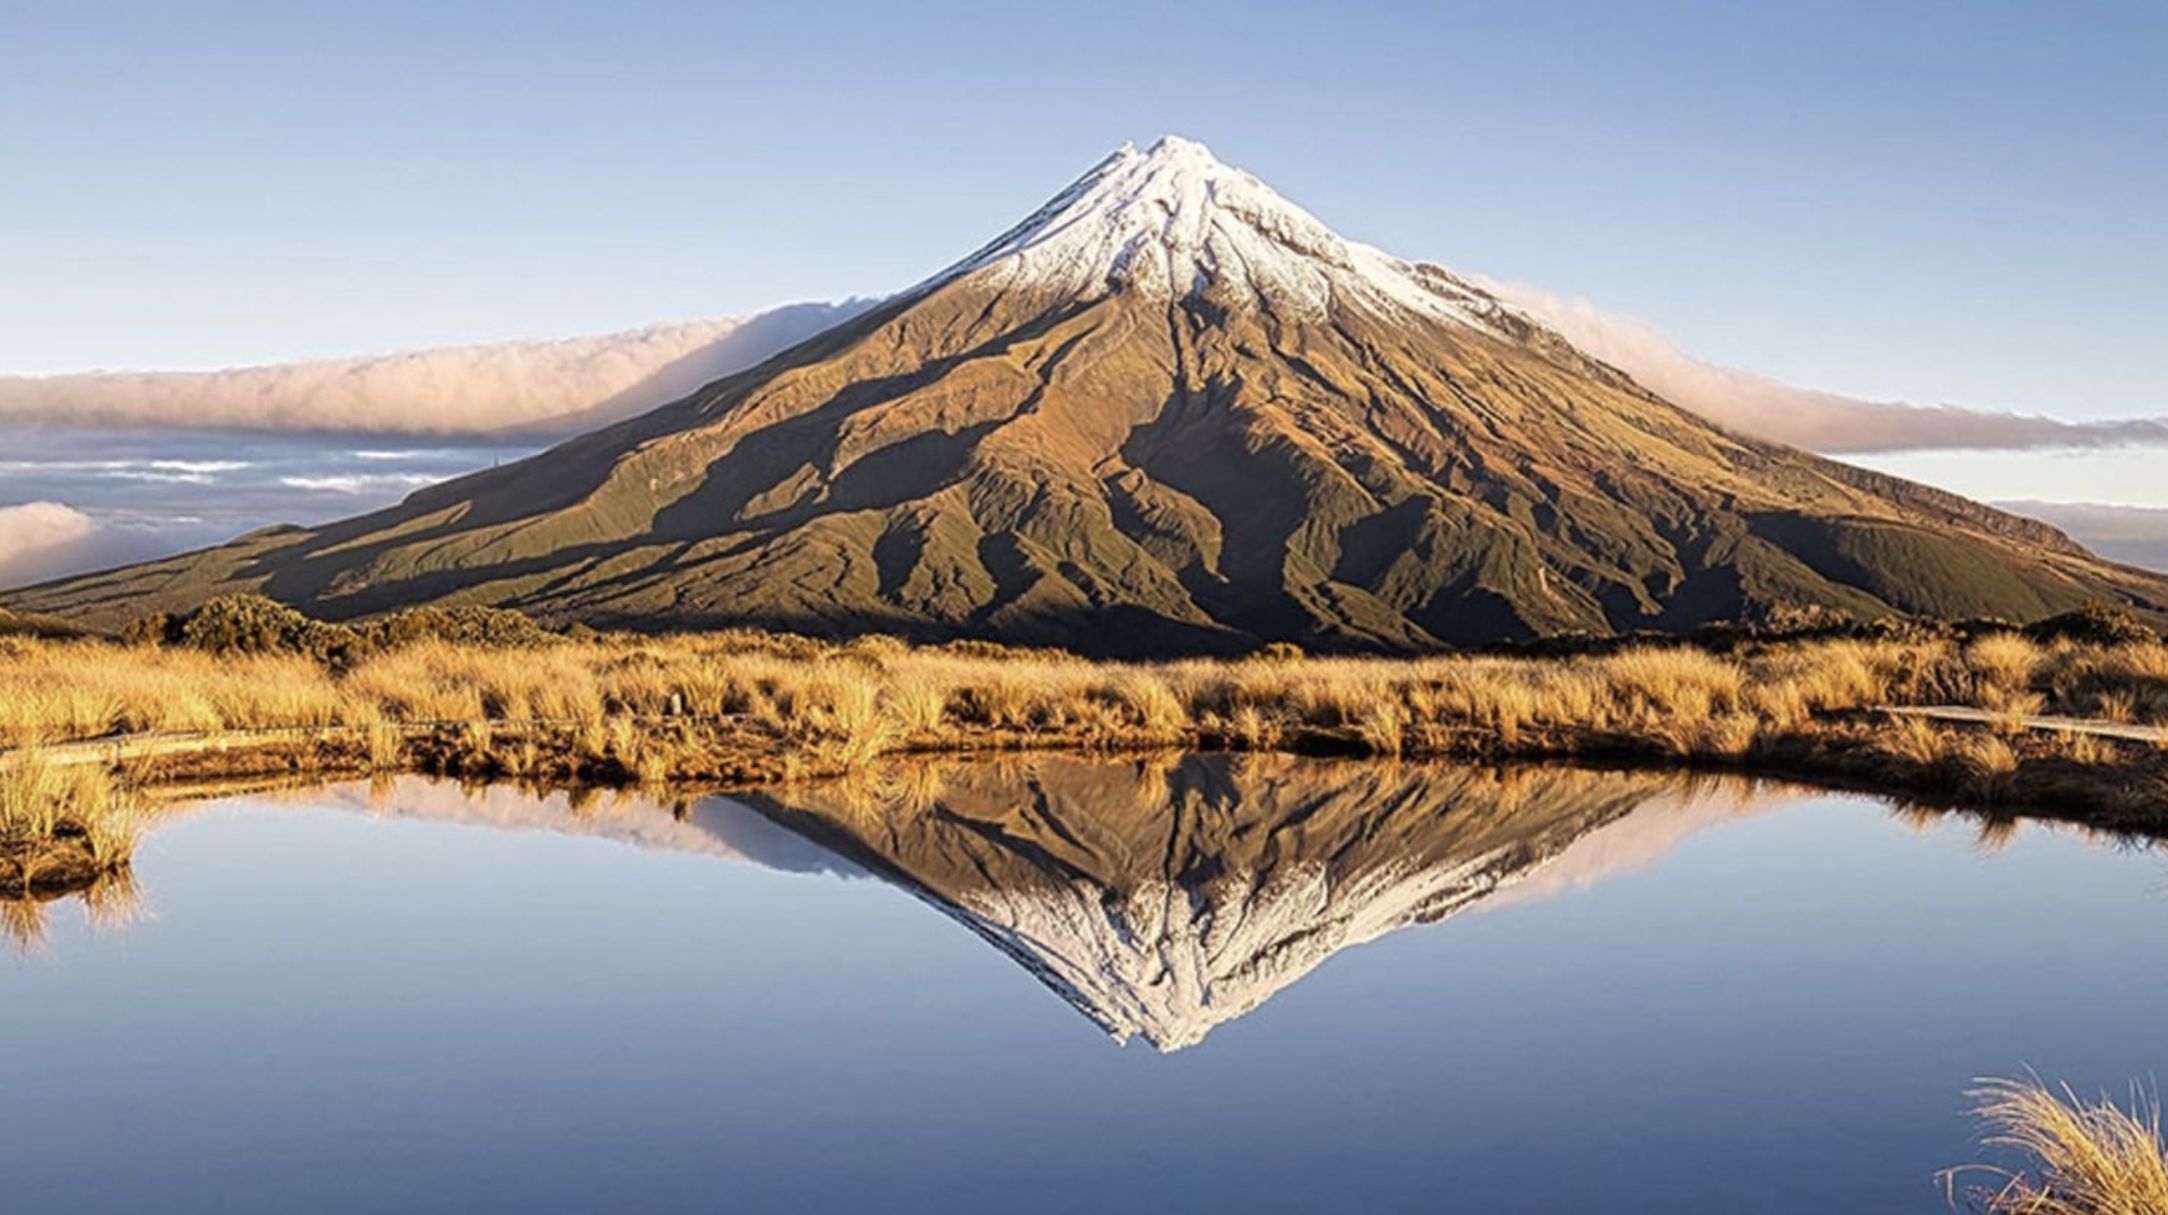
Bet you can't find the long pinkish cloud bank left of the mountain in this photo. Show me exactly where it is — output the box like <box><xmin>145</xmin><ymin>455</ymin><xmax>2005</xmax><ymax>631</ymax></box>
<box><xmin>0</xmin><ymin>299</ymin><xmax>867</xmax><ymax>434</ymax></box>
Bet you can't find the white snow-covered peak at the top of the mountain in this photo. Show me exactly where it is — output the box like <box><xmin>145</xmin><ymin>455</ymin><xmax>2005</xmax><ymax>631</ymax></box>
<box><xmin>926</xmin><ymin>135</ymin><xmax>1498</xmax><ymax>328</ymax></box>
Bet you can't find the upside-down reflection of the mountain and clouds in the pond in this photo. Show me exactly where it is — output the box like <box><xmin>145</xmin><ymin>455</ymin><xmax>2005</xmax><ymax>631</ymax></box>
<box><xmin>0</xmin><ymin>755</ymin><xmax>1789</xmax><ymax>1050</ymax></box>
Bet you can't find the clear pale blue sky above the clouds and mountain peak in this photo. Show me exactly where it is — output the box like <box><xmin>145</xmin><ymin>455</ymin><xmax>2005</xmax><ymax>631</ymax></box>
<box><xmin>0</xmin><ymin>0</ymin><xmax>2168</xmax><ymax>417</ymax></box>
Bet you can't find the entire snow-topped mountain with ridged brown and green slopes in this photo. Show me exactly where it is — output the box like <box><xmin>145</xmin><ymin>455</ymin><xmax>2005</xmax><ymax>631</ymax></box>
<box><xmin>0</xmin><ymin>137</ymin><xmax>2168</xmax><ymax>653</ymax></box>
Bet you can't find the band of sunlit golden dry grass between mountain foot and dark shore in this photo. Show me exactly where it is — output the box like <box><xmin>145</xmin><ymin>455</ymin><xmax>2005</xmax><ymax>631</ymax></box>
<box><xmin>0</xmin><ymin>634</ymin><xmax>1916</xmax><ymax>746</ymax></box>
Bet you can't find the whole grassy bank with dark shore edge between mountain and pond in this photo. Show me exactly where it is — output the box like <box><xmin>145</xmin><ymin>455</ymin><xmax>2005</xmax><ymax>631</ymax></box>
<box><xmin>0</xmin><ymin>603</ymin><xmax>2168</xmax><ymax>829</ymax></box>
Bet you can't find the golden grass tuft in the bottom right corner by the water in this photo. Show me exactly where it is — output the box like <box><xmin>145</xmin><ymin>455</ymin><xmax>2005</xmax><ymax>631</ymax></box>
<box><xmin>1971</xmin><ymin>1080</ymin><xmax>2168</xmax><ymax>1215</ymax></box>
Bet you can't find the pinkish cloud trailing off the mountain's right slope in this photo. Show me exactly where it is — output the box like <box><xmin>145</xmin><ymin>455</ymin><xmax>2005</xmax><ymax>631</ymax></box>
<box><xmin>1476</xmin><ymin>278</ymin><xmax>2168</xmax><ymax>453</ymax></box>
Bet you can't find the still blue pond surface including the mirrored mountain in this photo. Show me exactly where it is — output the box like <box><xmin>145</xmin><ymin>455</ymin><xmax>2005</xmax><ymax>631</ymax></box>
<box><xmin>0</xmin><ymin>759</ymin><xmax>2168</xmax><ymax>1215</ymax></box>
